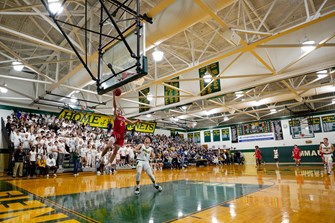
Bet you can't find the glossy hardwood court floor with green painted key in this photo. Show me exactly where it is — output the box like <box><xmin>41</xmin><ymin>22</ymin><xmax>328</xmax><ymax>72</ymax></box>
<box><xmin>0</xmin><ymin>165</ymin><xmax>335</xmax><ymax>223</ymax></box>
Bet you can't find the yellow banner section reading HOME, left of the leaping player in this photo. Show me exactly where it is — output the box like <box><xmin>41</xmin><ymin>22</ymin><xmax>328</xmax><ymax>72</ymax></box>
<box><xmin>58</xmin><ymin>109</ymin><xmax>114</xmax><ymax>128</ymax></box>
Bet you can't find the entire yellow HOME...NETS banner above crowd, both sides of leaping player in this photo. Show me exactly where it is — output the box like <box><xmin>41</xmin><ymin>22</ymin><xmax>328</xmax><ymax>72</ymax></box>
<box><xmin>58</xmin><ymin>109</ymin><xmax>156</xmax><ymax>133</ymax></box>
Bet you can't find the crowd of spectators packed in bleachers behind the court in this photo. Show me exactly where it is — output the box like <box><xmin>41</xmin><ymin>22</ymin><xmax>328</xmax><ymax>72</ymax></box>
<box><xmin>2</xmin><ymin>112</ymin><xmax>243</xmax><ymax>178</ymax></box>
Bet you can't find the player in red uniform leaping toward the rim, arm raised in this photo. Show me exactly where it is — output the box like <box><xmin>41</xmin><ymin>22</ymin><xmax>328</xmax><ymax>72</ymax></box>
<box><xmin>101</xmin><ymin>92</ymin><xmax>139</xmax><ymax>166</ymax></box>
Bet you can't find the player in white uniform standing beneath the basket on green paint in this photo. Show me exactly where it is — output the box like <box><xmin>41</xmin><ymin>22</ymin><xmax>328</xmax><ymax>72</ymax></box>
<box><xmin>134</xmin><ymin>136</ymin><xmax>162</xmax><ymax>195</ymax></box>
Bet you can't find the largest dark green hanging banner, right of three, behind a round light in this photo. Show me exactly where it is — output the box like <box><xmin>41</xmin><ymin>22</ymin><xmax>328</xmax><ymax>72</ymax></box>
<box><xmin>199</xmin><ymin>62</ymin><xmax>221</xmax><ymax>96</ymax></box>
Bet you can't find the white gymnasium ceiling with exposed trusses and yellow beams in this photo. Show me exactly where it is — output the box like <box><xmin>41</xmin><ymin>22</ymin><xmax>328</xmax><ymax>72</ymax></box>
<box><xmin>0</xmin><ymin>0</ymin><xmax>335</xmax><ymax>128</ymax></box>
